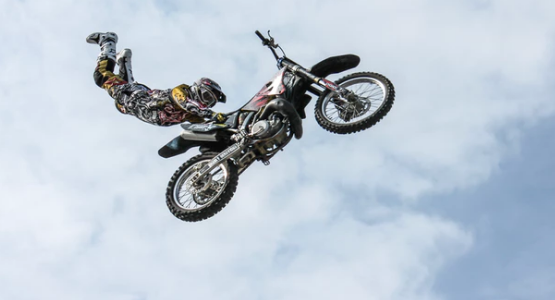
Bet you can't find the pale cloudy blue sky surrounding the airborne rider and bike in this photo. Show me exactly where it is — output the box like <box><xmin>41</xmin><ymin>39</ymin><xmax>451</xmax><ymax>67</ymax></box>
<box><xmin>0</xmin><ymin>0</ymin><xmax>555</xmax><ymax>300</ymax></box>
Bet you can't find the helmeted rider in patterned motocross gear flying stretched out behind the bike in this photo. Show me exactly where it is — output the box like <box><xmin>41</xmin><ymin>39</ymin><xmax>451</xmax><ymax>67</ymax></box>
<box><xmin>87</xmin><ymin>32</ymin><xmax>226</xmax><ymax>126</ymax></box>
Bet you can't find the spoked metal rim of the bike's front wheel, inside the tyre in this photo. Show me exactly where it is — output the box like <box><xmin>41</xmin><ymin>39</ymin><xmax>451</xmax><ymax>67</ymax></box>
<box><xmin>320</xmin><ymin>78</ymin><xmax>387</xmax><ymax>125</ymax></box>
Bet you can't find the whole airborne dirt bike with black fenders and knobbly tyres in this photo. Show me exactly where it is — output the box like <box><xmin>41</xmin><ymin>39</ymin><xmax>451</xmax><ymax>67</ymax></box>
<box><xmin>158</xmin><ymin>30</ymin><xmax>395</xmax><ymax>222</ymax></box>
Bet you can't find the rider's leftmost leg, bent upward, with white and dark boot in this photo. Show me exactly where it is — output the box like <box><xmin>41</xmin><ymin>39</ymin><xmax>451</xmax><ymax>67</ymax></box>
<box><xmin>87</xmin><ymin>32</ymin><xmax>127</xmax><ymax>94</ymax></box>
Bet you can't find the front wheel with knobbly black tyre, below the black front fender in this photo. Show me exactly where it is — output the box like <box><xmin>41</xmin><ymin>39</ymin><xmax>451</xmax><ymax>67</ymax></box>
<box><xmin>314</xmin><ymin>72</ymin><xmax>395</xmax><ymax>134</ymax></box>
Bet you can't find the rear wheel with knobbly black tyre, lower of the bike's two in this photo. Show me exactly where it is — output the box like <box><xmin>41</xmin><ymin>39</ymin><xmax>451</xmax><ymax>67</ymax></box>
<box><xmin>166</xmin><ymin>153</ymin><xmax>239</xmax><ymax>222</ymax></box>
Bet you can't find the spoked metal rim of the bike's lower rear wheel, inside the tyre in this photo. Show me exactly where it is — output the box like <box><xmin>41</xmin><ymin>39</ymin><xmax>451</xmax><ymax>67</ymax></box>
<box><xmin>173</xmin><ymin>160</ymin><xmax>229</xmax><ymax>212</ymax></box>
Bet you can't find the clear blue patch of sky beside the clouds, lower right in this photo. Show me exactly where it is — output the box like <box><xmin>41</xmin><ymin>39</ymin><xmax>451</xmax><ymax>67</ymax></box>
<box><xmin>432</xmin><ymin>119</ymin><xmax>555</xmax><ymax>299</ymax></box>
